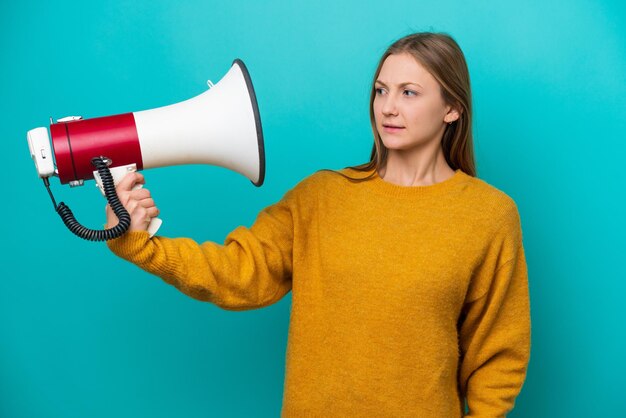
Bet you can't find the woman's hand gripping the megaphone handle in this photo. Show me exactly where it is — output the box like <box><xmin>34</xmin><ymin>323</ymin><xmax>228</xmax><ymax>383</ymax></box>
<box><xmin>106</xmin><ymin>172</ymin><xmax>159</xmax><ymax>231</ymax></box>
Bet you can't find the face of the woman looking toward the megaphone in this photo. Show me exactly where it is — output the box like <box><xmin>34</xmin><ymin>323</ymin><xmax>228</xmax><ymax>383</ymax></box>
<box><xmin>373</xmin><ymin>53</ymin><xmax>459</xmax><ymax>150</ymax></box>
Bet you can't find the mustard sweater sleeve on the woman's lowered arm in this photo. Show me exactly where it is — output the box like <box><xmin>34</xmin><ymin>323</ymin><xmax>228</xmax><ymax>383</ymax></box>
<box><xmin>459</xmin><ymin>208</ymin><xmax>530</xmax><ymax>418</ymax></box>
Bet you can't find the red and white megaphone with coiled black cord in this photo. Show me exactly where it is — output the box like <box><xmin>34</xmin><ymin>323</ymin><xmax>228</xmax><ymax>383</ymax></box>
<box><xmin>27</xmin><ymin>59</ymin><xmax>265</xmax><ymax>241</ymax></box>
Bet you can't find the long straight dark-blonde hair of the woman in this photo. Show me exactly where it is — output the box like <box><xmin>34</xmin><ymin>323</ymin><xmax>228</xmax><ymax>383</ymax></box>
<box><xmin>340</xmin><ymin>32</ymin><xmax>476</xmax><ymax>180</ymax></box>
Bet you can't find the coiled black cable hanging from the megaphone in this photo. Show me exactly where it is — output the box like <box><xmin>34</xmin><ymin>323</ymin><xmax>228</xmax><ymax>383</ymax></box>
<box><xmin>49</xmin><ymin>157</ymin><xmax>130</xmax><ymax>241</ymax></box>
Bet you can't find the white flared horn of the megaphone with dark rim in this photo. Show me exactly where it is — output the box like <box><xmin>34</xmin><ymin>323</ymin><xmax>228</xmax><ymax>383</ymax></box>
<box><xmin>133</xmin><ymin>60</ymin><xmax>261</xmax><ymax>183</ymax></box>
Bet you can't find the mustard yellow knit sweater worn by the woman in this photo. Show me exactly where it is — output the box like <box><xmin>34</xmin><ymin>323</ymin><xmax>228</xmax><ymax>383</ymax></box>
<box><xmin>109</xmin><ymin>169</ymin><xmax>530</xmax><ymax>418</ymax></box>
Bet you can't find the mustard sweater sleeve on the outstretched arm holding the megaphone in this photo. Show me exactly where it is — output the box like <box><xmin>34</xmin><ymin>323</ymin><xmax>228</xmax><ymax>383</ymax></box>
<box><xmin>108</xmin><ymin>183</ymin><xmax>297</xmax><ymax>310</ymax></box>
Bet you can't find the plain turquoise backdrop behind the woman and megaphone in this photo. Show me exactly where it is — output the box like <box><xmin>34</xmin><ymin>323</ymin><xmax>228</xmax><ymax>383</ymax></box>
<box><xmin>0</xmin><ymin>0</ymin><xmax>626</xmax><ymax>418</ymax></box>
